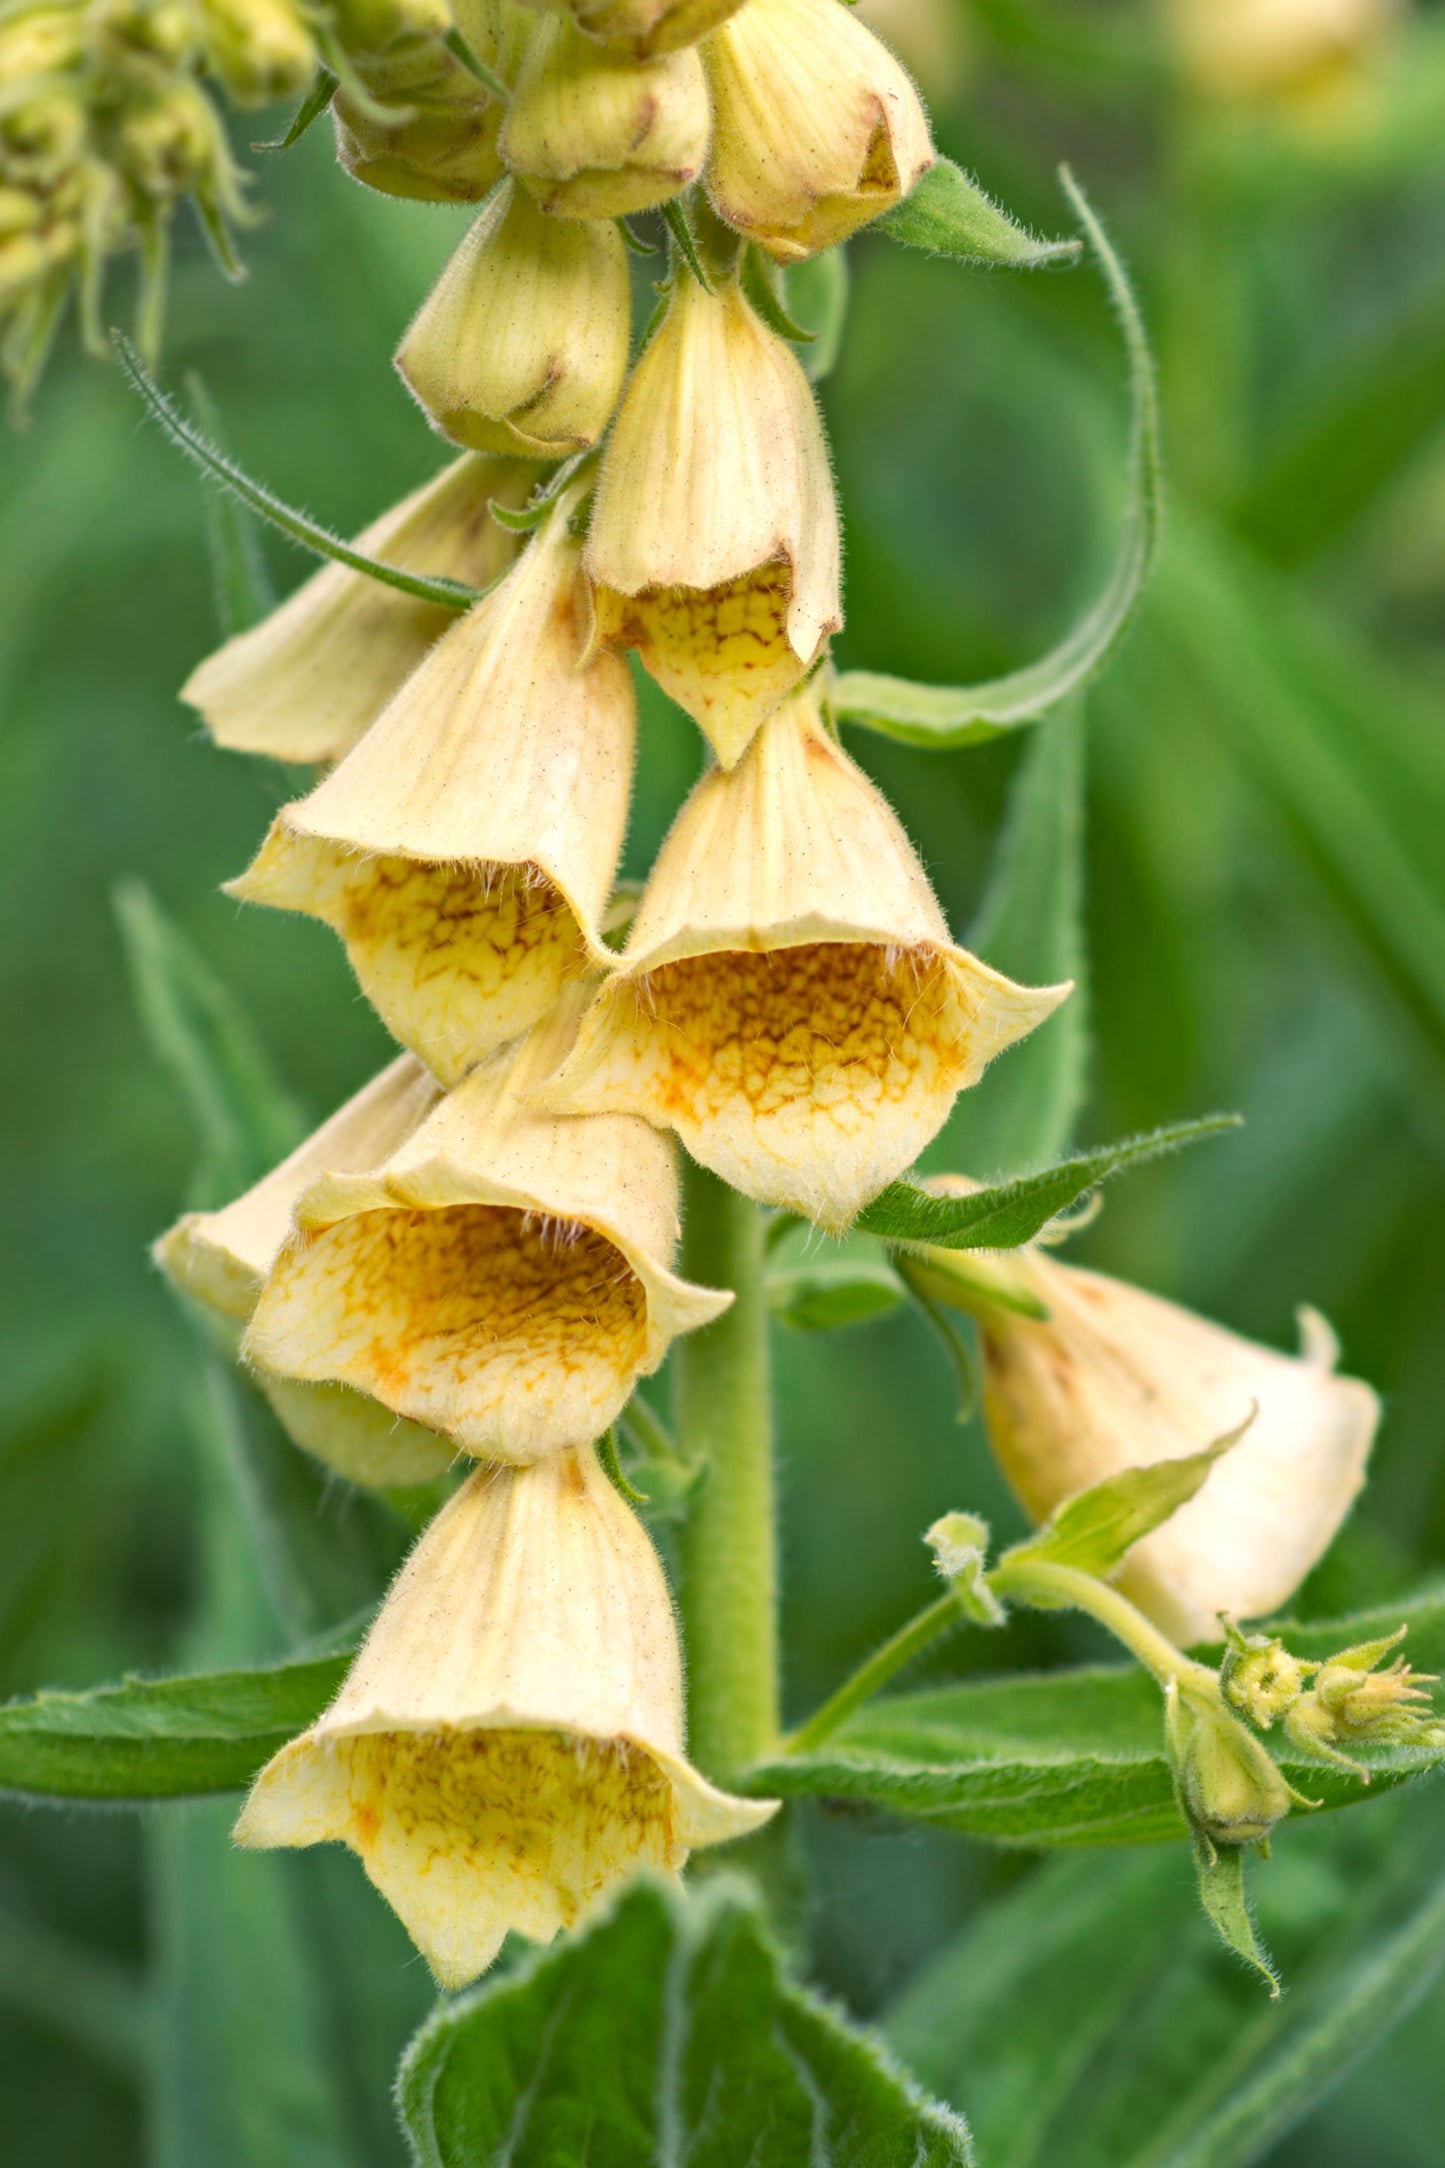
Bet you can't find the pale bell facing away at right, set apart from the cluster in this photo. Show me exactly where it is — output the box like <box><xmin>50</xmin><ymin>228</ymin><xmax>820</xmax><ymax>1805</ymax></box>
<box><xmin>968</xmin><ymin>1249</ymin><xmax>1380</xmax><ymax>1643</ymax></box>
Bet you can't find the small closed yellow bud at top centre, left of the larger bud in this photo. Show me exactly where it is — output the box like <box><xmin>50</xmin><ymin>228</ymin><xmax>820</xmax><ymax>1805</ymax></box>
<box><xmin>498</xmin><ymin>15</ymin><xmax>711</xmax><ymax>219</ymax></box>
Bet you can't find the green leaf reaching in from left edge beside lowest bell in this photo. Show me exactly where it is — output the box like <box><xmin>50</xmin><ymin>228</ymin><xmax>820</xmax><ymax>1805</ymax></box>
<box><xmin>0</xmin><ymin>1654</ymin><xmax>351</xmax><ymax>1799</ymax></box>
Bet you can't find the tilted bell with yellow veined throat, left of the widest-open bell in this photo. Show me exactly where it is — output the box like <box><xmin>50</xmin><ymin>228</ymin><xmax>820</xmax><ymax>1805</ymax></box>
<box><xmin>230</xmin><ymin>498</ymin><xmax>635</xmax><ymax>1084</ymax></box>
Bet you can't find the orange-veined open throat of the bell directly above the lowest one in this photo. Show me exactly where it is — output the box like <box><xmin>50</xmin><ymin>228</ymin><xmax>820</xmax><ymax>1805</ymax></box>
<box><xmin>247</xmin><ymin>1203</ymin><xmax>648</xmax><ymax>1461</ymax></box>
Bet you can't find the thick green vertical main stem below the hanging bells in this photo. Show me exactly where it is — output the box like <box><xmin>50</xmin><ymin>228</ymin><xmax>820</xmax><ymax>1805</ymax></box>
<box><xmin>676</xmin><ymin>1164</ymin><xmax>778</xmax><ymax>1784</ymax></box>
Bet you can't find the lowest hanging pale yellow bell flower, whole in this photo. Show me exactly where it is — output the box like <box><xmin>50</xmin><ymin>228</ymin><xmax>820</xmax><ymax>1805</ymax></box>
<box><xmin>236</xmin><ymin>1446</ymin><xmax>776</xmax><ymax>1988</ymax></box>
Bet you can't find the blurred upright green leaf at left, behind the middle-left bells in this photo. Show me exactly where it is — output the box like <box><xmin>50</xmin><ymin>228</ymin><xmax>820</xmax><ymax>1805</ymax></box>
<box><xmin>115</xmin><ymin>880</ymin><xmax>305</xmax><ymax>1208</ymax></box>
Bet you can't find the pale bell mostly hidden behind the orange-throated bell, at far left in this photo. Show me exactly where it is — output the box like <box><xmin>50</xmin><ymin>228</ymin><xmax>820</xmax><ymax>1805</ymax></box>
<box><xmin>154</xmin><ymin>1054</ymin><xmax>455</xmax><ymax>1487</ymax></box>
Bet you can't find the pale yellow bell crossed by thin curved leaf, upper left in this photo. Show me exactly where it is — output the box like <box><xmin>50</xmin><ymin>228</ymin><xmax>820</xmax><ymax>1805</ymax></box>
<box><xmin>180</xmin><ymin>453</ymin><xmax>537</xmax><ymax>761</ymax></box>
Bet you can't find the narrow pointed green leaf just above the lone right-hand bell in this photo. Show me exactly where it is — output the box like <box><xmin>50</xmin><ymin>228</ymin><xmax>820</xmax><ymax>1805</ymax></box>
<box><xmin>854</xmin><ymin>1114</ymin><xmax>1239</xmax><ymax>1249</ymax></box>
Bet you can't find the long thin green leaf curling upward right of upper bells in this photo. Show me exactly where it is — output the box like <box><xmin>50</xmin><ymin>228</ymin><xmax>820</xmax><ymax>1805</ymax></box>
<box><xmin>832</xmin><ymin>169</ymin><xmax>1163</xmax><ymax>750</ymax></box>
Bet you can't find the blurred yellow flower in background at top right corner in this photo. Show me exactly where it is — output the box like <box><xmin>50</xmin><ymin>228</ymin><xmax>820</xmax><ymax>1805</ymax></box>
<box><xmin>1170</xmin><ymin>0</ymin><xmax>1402</xmax><ymax>113</ymax></box>
